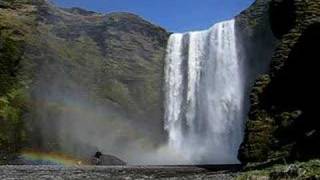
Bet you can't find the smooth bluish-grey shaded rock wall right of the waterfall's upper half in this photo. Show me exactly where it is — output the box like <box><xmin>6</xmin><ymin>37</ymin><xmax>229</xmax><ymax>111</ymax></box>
<box><xmin>236</xmin><ymin>0</ymin><xmax>277</xmax><ymax>79</ymax></box>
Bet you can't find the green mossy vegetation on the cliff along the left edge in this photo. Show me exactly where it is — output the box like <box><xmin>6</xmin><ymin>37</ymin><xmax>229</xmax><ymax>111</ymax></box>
<box><xmin>0</xmin><ymin>1</ymin><xmax>34</xmax><ymax>164</ymax></box>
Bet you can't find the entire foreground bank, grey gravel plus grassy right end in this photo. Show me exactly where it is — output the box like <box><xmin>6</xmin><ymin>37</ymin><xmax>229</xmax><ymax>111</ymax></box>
<box><xmin>0</xmin><ymin>160</ymin><xmax>320</xmax><ymax>180</ymax></box>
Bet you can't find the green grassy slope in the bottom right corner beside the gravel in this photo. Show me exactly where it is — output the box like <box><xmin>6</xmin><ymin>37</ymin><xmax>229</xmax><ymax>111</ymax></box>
<box><xmin>236</xmin><ymin>160</ymin><xmax>320</xmax><ymax>180</ymax></box>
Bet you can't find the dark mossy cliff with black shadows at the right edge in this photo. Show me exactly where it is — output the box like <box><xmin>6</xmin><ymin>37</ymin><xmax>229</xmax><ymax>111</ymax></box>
<box><xmin>239</xmin><ymin>0</ymin><xmax>320</xmax><ymax>163</ymax></box>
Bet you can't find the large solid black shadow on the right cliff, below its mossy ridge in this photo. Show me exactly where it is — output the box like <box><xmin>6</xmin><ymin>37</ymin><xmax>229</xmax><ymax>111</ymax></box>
<box><xmin>265</xmin><ymin>23</ymin><xmax>320</xmax><ymax>160</ymax></box>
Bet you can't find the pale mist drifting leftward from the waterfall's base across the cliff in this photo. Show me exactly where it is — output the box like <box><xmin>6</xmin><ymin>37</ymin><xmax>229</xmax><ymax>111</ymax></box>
<box><xmin>24</xmin><ymin>50</ymin><xmax>176</xmax><ymax>165</ymax></box>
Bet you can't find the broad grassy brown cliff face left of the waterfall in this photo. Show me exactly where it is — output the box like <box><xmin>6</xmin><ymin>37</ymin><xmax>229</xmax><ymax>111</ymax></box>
<box><xmin>0</xmin><ymin>0</ymin><xmax>168</xmax><ymax>163</ymax></box>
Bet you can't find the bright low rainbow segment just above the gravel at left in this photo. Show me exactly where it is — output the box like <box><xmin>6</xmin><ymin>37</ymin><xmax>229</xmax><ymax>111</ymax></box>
<box><xmin>21</xmin><ymin>149</ymin><xmax>89</xmax><ymax>166</ymax></box>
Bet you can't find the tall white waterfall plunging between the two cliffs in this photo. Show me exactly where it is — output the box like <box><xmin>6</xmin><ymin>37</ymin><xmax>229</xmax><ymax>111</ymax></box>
<box><xmin>165</xmin><ymin>20</ymin><xmax>244</xmax><ymax>164</ymax></box>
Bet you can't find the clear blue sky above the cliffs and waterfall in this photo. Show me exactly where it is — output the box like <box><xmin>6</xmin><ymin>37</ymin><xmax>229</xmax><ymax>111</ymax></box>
<box><xmin>52</xmin><ymin>0</ymin><xmax>254</xmax><ymax>32</ymax></box>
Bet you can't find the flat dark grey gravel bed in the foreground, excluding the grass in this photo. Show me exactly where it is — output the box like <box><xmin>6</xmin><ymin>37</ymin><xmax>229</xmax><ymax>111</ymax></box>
<box><xmin>0</xmin><ymin>166</ymin><xmax>234</xmax><ymax>180</ymax></box>
